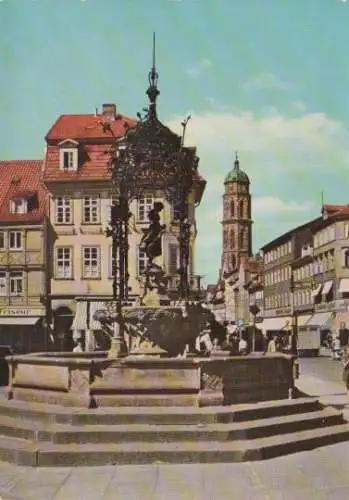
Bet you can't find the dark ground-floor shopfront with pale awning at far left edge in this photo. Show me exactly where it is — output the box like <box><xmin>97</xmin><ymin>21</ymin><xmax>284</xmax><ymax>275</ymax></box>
<box><xmin>0</xmin><ymin>307</ymin><xmax>48</xmax><ymax>353</ymax></box>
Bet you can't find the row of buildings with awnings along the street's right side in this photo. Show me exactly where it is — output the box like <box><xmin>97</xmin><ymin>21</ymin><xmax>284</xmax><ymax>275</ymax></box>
<box><xmin>262</xmin><ymin>205</ymin><xmax>349</xmax><ymax>340</ymax></box>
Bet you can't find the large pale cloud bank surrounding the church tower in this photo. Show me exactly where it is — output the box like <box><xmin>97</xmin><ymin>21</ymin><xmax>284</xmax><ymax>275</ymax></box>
<box><xmin>166</xmin><ymin>107</ymin><xmax>349</xmax><ymax>281</ymax></box>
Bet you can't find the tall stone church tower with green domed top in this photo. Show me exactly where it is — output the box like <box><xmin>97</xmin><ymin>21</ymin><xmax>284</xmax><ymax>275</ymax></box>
<box><xmin>221</xmin><ymin>154</ymin><xmax>252</xmax><ymax>274</ymax></box>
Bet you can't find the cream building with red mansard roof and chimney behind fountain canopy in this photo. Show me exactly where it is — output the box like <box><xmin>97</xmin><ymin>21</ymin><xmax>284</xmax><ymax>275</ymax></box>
<box><xmin>43</xmin><ymin>104</ymin><xmax>205</xmax><ymax>348</ymax></box>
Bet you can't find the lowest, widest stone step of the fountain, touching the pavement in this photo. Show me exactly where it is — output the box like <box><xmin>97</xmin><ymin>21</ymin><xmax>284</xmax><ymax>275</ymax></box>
<box><xmin>0</xmin><ymin>424</ymin><xmax>349</xmax><ymax>467</ymax></box>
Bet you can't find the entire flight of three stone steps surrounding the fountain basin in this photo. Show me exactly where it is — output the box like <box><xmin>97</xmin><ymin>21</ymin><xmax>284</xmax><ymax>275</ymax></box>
<box><xmin>0</xmin><ymin>398</ymin><xmax>349</xmax><ymax>467</ymax></box>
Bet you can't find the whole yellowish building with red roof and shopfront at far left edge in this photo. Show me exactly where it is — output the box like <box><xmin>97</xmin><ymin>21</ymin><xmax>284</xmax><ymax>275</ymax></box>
<box><xmin>0</xmin><ymin>160</ymin><xmax>50</xmax><ymax>352</ymax></box>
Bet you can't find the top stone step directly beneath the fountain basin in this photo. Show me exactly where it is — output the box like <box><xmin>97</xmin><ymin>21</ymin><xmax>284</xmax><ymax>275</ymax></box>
<box><xmin>0</xmin><ymin>397</ymin><xmax>322</xmax><ymax>426</ymax></box>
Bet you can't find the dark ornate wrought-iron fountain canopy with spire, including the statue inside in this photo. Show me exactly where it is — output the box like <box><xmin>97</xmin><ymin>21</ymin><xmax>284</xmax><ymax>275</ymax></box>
<box><xmin>107</xmin><ymin>34</ymin><xmax>199</xmax><ymax>357</ymax></box>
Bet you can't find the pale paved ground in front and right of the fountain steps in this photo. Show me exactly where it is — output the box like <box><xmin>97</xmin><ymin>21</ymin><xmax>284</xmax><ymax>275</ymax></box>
<box><xmin>0</xmin><ymin>374</ymin><xmax>349</xmax><ymax>500</ymax></box>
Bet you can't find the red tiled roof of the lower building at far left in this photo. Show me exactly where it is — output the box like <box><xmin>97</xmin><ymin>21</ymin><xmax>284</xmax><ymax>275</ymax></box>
<box><xmin>0</xmin><ymin>160</ymin><xmax>47</xmax><ymax>223</ymax></box>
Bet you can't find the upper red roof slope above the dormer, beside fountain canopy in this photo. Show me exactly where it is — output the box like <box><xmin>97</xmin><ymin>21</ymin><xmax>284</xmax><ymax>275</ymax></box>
<box><xmin>45</xmin><ymin>115</ymin><xmax>136</xmax><ymax>142</ymax></box>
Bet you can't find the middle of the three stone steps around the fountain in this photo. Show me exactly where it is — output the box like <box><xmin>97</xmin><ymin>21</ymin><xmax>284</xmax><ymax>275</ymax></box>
<box><xmin>0</xmin><ymin>408</ymin><xmax>343</xmax><ymax>444</ymax></box>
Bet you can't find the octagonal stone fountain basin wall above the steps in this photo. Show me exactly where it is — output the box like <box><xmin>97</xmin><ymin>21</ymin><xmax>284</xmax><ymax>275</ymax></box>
<box><xmin>6</xmin><ymin>352</ymin><xmax>294</xmax><ymax>408</ymax></box>
